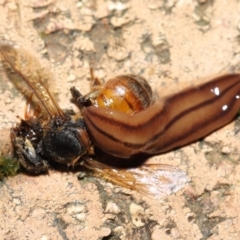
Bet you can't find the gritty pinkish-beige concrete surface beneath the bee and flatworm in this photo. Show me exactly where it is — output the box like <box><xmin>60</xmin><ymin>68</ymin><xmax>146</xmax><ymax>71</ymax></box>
<box><xmin>0</xmin><ymin>0</ymin><xmax>240</xmax><ymax>240</ymax></box>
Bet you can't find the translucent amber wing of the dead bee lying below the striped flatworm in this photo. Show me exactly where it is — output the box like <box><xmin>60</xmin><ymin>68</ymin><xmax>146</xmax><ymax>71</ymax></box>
<box><xmin>84</xmin><ymin>159</ymin><xmax>189</xmax><ymax>200</ymax></box>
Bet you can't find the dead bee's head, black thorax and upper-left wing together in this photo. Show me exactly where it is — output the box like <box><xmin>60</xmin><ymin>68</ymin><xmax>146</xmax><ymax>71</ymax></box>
<box><xmin>0</xmin><ymin>44</ymin><xmax>92</xmax><ymax>173</ymax></box>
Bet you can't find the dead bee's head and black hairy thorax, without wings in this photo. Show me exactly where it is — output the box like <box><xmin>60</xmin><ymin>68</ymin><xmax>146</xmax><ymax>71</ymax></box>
<box><xmin>11</xmin><ymin>115</ymin><xmax>92</xmax><ymax>173</ymax></box>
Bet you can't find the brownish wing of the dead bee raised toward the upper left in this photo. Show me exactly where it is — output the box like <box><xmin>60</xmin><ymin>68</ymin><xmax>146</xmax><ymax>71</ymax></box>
<box><xmin>0</xmin><ymin>44</ymin><xmax>65</xmax><ymax>118</ymax></box>
